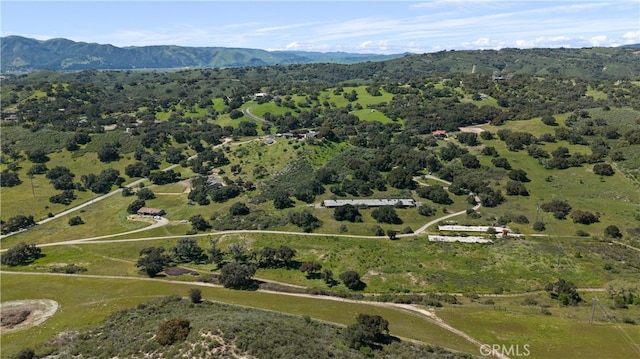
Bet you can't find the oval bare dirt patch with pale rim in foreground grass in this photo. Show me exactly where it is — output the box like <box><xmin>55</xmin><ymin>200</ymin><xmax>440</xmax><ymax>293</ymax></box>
<box><xmin>0</xmin><ymin>299</ymin><xmax>58</xmax><ymax>334</ymax></box>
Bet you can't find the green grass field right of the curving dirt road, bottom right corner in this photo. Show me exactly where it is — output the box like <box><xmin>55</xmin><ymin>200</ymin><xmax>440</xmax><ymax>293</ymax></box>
<box><xmin>436</xmin><ymin>294</ymin><xmax>640</xmax><ymax>358</ymax></box>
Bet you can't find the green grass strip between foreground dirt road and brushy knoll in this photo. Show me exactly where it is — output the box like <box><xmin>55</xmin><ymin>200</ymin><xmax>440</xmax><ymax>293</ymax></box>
<box><xmin>0</xmin><ymin>273</ymin><xmax>475</xmax><ymax>356</ymax></box>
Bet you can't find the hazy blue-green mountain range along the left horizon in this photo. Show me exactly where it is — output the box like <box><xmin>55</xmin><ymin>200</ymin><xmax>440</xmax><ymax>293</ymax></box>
<box><xmin>0</xmin><ymin>36</ymin><xmax>403</xmax><ymax>73</ymax></box>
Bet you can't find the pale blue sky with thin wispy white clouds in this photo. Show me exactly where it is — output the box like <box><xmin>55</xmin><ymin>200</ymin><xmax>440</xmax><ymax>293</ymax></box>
<box><xmin>0</xmin><ymin>0</ymin><xmax>640</xmax><ymax>54</ymax></box>
